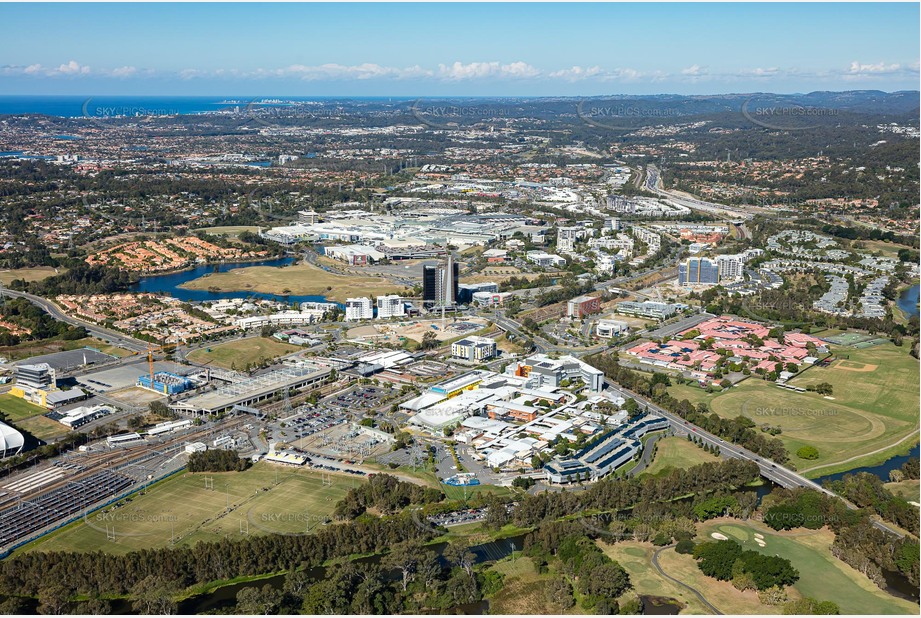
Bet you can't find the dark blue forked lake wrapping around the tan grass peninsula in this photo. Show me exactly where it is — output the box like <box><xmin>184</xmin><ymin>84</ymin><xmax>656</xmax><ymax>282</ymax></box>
<box><xmin>131</xmin><ymin>257</ymin><xmax>327</xmax><ymax>303</ymax></box>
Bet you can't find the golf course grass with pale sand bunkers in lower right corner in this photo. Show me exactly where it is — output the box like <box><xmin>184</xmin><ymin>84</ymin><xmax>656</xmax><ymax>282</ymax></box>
<box><xmin>700</xmin><ymin>520</ymin><xmax>918</xmax><ymax>615</ymax></box>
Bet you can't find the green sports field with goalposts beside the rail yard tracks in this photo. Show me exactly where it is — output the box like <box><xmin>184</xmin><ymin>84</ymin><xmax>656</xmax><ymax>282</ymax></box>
<box><xmin>22</xmin><ymin>462</ymin><xmax>362</xmax><ymax>554</ymax></box>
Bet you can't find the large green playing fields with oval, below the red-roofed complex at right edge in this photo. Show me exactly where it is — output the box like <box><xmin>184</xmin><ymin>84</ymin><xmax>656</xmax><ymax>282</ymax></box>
<box><xmin>669</xmin><ymin>343</ymin><xmax>919</xmax><ymax>477</ymax></box>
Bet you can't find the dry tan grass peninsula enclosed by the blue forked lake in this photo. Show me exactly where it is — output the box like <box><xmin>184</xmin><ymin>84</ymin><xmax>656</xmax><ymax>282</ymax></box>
<box><xmin>180</xmin><ymin>263</ymin><xmax>403</xmax><ymax>302</ymax></box>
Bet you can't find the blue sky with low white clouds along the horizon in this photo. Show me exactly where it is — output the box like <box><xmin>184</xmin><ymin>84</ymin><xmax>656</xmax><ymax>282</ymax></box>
<box><xmin>0</xmin><ymin>3</ymin><xmax>921</xmax><ymax>96</ymax></box>
